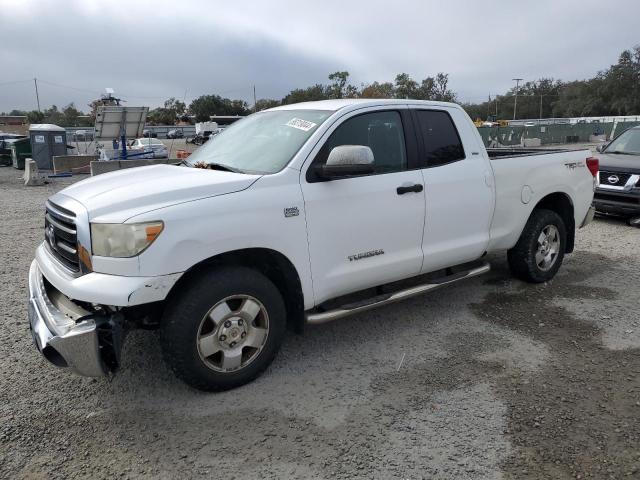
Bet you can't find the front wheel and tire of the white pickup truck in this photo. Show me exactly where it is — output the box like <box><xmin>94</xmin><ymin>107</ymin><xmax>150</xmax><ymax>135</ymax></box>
<box><xmin>160</xmin><ymin>267</ymin><xmax>286</xmax><ymax>392</ymax></box>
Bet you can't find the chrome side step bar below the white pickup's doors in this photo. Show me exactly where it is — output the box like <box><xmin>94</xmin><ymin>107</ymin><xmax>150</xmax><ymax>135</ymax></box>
<box><xmin>305</xmin><ymin>263</ymin><xmax>491</xmax><ymax>325</ymax></box>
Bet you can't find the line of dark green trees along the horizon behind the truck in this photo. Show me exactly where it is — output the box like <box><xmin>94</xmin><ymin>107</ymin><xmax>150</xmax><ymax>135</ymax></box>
<box><xmin>3</xmin><ymin>45</ymin><xmax>640</xmax><ymax>126</ymax></box>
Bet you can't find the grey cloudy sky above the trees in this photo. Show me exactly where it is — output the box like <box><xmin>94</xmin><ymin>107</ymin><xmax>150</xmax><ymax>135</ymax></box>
<box><xmin>0</xmin><ymin>0</ymin><xmax>640</xmax><ymax>111</ymax></box>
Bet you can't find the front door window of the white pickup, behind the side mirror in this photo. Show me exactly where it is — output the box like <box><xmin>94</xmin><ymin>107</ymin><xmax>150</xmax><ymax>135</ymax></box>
<box><xmin>307</xmin><ymin>111</ymin><xmax>407</xmax><ymax>181</ymax></box>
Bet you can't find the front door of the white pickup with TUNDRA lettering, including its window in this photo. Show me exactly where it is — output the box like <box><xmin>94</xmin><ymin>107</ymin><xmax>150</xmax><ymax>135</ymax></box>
<box><xmin>301</xmin><ymin>108</ymin><xmax>425</xmax><ymax>304</ymax></box>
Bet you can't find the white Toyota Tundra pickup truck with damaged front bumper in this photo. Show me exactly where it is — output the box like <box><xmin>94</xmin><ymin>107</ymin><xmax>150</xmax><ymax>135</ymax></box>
<box><xmin>29</xmin><ymin>100</ymin><xmax>598</xmax><ymax>391</ymax></box>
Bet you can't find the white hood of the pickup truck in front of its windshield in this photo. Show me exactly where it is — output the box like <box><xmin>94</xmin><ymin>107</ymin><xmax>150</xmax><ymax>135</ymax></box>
<box><xmin>60</xmin><ymin>165</ymin><xmax>260</xmax><ymax>219</ymax></box>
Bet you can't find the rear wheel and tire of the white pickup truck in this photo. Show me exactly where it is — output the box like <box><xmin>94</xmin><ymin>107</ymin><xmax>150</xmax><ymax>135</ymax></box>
<box><xmin>507</xmin><ymin>209</ymin><xmax>567</xmax><ymax>283</ymax></box>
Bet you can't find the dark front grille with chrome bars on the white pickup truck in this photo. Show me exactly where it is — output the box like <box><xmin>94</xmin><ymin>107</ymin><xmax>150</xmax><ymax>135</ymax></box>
<box><xmin>44</xmin><ymin>202</ymin><xmax>80</xmax><ymax>272</ymax></box>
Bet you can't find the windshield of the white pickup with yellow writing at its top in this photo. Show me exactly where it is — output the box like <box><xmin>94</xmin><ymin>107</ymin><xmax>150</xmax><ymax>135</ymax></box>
<box><xmin>188</xmin><ymin>110</ymin><xmax>333</xmax><ymax>173</ymax></box>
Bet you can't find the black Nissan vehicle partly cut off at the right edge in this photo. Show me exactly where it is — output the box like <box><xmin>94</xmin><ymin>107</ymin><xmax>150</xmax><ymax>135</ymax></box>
<box><xmin>593</xmin><ymin>126</ymin><xmax>640</xmax><ymax>223</ymax></box>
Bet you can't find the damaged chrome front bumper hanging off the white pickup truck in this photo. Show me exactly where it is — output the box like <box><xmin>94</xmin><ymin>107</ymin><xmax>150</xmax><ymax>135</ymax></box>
<box><xmin>29</xmin><ymin>260</ymin><xmax>124</xmax><ymax>377</ymax></box>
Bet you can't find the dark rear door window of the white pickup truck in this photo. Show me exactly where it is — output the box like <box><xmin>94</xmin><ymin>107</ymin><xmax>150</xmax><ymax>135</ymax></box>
<box><xmin>415</xmin><ymin>110</ymin><xmax>465</xmax><ymax>167</ymax></box>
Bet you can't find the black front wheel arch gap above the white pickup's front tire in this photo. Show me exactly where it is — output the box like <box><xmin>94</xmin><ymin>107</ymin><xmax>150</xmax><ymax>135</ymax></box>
<box><xmin>167</xmin><ymin>248</ymin><xmax>304</xmax><ymax>333</ymax></box>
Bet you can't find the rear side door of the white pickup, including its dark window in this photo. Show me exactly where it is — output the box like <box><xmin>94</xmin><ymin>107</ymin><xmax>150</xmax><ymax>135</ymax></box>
<box><xmin>412</xmin><ymin>108</ymin><xmax>494</xmax><ymax>273</ymax></box>
